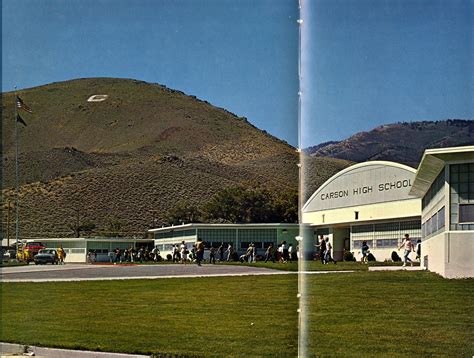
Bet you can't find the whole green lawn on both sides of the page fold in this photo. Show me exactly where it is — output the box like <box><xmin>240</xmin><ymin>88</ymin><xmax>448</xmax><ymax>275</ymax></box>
<box><xmin>1</xmin><ymin>272</ymin><xmax>474</xmax><ymax>357</ymax></box>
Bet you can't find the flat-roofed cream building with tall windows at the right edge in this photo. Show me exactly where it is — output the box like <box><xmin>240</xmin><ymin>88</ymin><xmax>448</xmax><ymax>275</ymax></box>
<box><xmin>410</xmin><ymin>146</ymin><xmax>474</xmax><ymax>278</ymax></box>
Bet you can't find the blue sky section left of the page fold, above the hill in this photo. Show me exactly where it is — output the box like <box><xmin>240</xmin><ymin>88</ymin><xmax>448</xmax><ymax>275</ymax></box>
<box><xmin>2</xmin><ymin>0</ymin><xmax>298</xmax><ymax>145</ymax></box>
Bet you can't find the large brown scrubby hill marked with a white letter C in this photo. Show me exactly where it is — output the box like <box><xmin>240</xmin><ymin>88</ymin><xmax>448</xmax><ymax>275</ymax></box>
<box><xmin>2</xmin><ymin>78</ymin><xmax>349</xmax><ymax>238</ymax></box>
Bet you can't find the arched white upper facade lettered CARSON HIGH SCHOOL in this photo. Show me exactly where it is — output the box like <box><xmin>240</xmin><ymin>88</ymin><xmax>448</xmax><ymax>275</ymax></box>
<box><xmin>303</xmin><ymin>162</ymin><xmax>415</xmax><ymax>212</ymax></box>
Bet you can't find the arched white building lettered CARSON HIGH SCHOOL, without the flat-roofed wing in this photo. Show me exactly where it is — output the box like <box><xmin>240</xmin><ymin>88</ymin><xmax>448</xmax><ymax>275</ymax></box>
<box><xmin>302</xmin><ymin>161</ymin><xmax>421</xmax><ymax>261</ymax></box>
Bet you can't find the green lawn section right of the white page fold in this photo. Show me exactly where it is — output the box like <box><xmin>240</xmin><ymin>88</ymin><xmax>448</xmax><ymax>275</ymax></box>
<box><xmin>307</xmin><ymin>271</ymin><xmax>474</xmax><ymax>357</ymax></box>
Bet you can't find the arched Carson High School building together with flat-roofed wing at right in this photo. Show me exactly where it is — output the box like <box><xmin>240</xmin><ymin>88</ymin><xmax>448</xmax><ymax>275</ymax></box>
<box><xmin>302</xmin><ymin>146</ymin><xmax>474</xmax><ymax>278</ymax></box>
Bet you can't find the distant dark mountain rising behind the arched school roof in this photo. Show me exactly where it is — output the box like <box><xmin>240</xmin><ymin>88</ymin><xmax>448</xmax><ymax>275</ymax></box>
<box><xmin>306</xmin><ymin>119</ymin><xmax>474</xmax><ymax>168</ymax></box>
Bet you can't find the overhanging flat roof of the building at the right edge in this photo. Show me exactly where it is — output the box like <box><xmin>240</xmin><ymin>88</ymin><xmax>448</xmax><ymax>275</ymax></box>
<box><xmin>410</xmin><ymin>145</ymin><xmax>474</xmax><ymax>197</ymax></box>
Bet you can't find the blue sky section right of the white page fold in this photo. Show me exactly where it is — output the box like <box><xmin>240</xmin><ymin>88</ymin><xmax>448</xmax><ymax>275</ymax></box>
<box><xmin>302</xmin><ymin>0</ymin><xmax>474</xmax><ymax>145</ymax></box>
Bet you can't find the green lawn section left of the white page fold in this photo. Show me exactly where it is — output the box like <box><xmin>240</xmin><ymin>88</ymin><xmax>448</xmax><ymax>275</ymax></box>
<box><xmin>0</xmin><ymin>275</ymin><xmax>298</xmax><ymax>356</ymax></box>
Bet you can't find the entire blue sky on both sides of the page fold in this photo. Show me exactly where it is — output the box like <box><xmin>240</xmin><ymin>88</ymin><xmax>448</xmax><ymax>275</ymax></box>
<box><xmin>2</xmin><ymin>0</ymin><xmax>474</xmax><ymax>146</ymax></box>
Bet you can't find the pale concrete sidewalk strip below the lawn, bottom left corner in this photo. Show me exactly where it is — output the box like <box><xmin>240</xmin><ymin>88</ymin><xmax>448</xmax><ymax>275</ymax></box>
<box><xmin>0</xmin><ymin>343</ymin><xmax>149</xmax><ymax>358</ymax></box>
